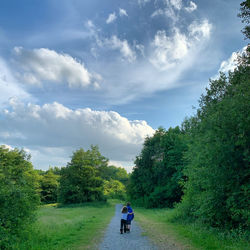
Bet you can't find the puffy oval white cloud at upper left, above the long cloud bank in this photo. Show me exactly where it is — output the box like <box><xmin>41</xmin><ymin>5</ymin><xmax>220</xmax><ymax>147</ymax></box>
<box><xmin>14</xmin><ymin>46</ymin><xmax>99</xmax><ymax>88</ymax></box>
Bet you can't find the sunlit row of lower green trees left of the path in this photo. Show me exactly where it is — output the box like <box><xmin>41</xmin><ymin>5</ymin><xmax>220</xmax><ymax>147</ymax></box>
<box><xmin>0</xmin><ymin>146</ymin><xmax>128</xmax><ymax>249</ymax></box>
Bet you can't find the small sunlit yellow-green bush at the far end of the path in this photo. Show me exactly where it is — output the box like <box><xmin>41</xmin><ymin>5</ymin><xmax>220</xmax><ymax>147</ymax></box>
<box><xmin>104</xmin><ymin>179</ymin><xmax>126</xmax><ymax>200</ymax></box>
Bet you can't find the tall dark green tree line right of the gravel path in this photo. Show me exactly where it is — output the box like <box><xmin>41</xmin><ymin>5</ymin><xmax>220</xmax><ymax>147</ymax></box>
<box><xmin>128</xmin><ymin>0</ymin><xmax>250</xmax><ymax>230</ymax></box>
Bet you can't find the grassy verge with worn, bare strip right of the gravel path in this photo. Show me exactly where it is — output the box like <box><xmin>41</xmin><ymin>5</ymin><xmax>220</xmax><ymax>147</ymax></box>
<box><xmin>135</xmin><ymin>208</ymin><xmax>250</xmax><ymax>250</ymax></box>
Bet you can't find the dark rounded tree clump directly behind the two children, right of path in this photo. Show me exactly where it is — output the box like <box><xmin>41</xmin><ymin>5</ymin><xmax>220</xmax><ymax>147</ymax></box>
<box><xmin>128</xmin><ymin>127</ymin><xmax>186</xmax><ymax>207</ymax></box>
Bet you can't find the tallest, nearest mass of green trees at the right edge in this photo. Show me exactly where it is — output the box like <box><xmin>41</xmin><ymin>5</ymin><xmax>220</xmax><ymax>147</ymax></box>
<box><xmin>180</xmin><ymin>66</ymin><xmax>250</xmax><ymax>228</ymax></box>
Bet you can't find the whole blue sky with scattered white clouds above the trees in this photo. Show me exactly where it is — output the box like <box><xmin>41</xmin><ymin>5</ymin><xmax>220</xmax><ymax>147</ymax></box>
<box><xmin>0</xmin><ymin>0</ymin><xmax>246</xmax><ymax>172</ymax></box>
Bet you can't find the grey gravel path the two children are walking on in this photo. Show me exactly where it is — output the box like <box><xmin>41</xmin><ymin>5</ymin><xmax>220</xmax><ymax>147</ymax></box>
<box><xmin>99</xmin><ymin>204</ymin><xmax>158</xmax><ymax>250</ymax></box>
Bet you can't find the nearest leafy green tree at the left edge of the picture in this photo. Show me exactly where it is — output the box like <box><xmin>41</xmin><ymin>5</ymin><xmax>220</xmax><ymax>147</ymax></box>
<box><xmin>0</xmin><ymin>146</ymin><xmax>39</xmax><ymax>249</ymax></box>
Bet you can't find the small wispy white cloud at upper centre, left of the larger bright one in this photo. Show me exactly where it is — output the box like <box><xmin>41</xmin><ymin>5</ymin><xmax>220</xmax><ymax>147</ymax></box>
<box><xmin>105</xmin><ymin>36</ymin><xmax>136</xmax><ymax>62</ymax></box>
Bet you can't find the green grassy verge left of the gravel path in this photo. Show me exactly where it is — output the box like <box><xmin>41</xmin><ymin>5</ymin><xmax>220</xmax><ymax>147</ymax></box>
<box><xmin>15</xmin><ymin>202</ymin><xmax>114</xmax><ymax>250</ymax></box>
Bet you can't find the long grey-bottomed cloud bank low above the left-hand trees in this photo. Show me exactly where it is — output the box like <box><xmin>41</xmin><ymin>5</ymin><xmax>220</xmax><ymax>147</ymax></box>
<box><xmin>0</xmin><ymin>100</ymin><xmax>154</xmax><ymax>165</ymax></box>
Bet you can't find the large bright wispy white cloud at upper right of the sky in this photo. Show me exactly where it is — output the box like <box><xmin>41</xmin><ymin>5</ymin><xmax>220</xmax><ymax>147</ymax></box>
<box><xmin>150</xmin><ymin>20</ymin><xmax>212</xmax><ymax>70</ymax></box>
